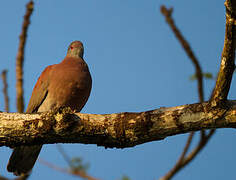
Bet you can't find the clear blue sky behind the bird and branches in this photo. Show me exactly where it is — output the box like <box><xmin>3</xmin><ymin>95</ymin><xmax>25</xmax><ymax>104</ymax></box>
<box><xmin>0</xmin><ymin>0</ymin><xmax>236</xmax><ymax>180</ymax></box>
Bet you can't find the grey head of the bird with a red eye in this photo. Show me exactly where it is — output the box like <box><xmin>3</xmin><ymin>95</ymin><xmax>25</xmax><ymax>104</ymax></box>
<box><xmin>66</xmin><ymin>41</ymin><xmax>84</xmax><ymax>58</ymax></box>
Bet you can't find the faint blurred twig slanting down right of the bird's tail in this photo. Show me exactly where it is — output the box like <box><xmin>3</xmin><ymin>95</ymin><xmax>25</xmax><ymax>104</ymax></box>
<box><xmin>39</xmin><ymin>159</ymin><xmax>99</xmax><ymax>180</ymax></box>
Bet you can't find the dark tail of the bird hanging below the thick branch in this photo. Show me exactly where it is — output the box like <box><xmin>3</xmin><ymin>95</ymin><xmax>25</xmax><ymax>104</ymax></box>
<box><xmin>7</xmin><ymin>145</ymin><xmax>42</xmax><ymax>176</ymax></box>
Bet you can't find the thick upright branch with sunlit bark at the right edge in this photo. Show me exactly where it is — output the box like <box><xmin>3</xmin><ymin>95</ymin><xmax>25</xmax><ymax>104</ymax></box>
<box><xmin>211</xmin><ymin>0</ymin><xmax>236</xmax><ymax>105</ymax></box>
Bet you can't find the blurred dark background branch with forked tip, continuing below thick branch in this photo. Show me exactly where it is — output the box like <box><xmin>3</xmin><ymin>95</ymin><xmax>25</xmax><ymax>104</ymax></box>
<box><xmin>161</xmin><ymin>6</ymin><xmax>215</xmax><ymax>180</ymax></box>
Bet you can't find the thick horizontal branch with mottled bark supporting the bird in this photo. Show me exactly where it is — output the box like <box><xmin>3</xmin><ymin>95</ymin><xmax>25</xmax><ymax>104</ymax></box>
<box><xmin>0</xmin><ymin>101</ymin><xmax>236</xmax><ymax>148</ymax></box>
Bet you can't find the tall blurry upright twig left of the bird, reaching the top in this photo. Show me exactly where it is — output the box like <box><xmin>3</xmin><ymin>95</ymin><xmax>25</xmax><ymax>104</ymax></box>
<box><xmin>16</xmin><ymin>0</ymin><xmax>34</xmax><ymax>112</ymax></box>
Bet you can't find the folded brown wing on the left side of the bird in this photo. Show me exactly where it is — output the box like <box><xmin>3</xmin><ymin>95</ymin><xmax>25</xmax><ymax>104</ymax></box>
<box><xmin>26</xmin><ymin>65</ymin><xmax>54</xmax><ymax>113</ymax></box>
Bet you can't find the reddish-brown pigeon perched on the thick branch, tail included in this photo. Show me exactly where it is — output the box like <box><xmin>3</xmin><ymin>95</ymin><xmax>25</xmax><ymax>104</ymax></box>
<box><xmin>7</xmin><ymin>41</ymin><xmax>92</xmax><ymax>175</ymax></box>
